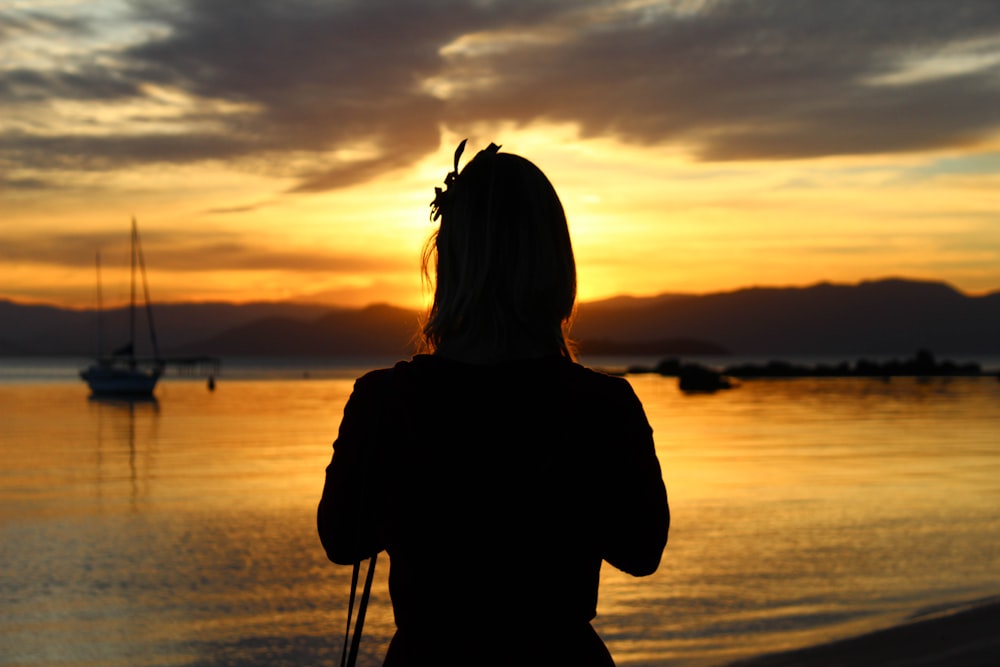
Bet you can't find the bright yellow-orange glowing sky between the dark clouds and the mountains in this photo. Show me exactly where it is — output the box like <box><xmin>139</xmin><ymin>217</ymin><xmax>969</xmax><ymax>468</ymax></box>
<box><xmin>4</xmin><ymin>125</ymin><xmax>1000</xmax><ymax>307</ymax></box>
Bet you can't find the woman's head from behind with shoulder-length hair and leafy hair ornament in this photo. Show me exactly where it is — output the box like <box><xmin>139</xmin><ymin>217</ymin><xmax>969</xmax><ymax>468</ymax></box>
<box><xmin>423</xmin><ymin>142</ymin><xmax>576</xmax><ymax>358</ymax></box>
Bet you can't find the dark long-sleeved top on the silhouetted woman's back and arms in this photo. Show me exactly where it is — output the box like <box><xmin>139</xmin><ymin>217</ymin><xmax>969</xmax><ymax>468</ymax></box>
<box><xmin>318</xmin><ymin>356</ymin><xmax>670</xmax><ymax>665</ymax></box>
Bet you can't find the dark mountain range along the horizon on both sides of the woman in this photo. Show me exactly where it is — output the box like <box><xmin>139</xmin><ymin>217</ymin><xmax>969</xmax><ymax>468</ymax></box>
<box><xmin>0</xmin><ymin>278</ymin><xmax>1000</xmax><ymax>358</ymax></box>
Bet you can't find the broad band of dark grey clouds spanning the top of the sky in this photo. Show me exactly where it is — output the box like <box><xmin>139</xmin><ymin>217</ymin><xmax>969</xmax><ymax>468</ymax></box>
<box><xmin>0</xmin><ymin>0</ymin><xmax>1000</xmax><ymax>192</ymax></box>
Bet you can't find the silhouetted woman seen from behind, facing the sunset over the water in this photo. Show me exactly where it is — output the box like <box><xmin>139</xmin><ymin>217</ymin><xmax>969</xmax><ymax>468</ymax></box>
<box><xmin>318</xmin><ymin>142</ymin><xmax>670</xmax><ymax>666</ymax></box>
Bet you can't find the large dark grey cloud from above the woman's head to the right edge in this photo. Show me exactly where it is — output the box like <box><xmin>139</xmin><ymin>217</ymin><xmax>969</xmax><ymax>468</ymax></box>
<box><xmin>449</xmin><ymin>0</ymin><xmax>1000</xmax><ymax>160</ymax></box>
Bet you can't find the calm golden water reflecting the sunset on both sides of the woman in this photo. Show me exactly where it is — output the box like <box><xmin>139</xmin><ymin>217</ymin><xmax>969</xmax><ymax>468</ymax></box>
<box><xmin>0</xmin><ymin>362</ymin><xmax>1000</xmax><ymax>667</ymax></box>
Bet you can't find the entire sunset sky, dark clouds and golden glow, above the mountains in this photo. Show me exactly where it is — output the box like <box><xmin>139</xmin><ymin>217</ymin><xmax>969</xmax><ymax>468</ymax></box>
<box><xmin>0</xmin><ymin>0</ymin><xmax>1000</xmax><ymax>307</ymax></box>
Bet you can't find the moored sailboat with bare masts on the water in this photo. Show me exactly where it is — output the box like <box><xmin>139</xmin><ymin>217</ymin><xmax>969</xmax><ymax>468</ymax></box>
<box><xmin>80</xmin><ymin>217</ymin><xmax>165</xmax><ymax>397</ymax></box>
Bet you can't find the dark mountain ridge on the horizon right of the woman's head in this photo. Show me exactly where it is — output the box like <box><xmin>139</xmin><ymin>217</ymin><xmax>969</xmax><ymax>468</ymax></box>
<box><xmin>573</xmin><ymin>279</ymin><xmax>1000</xmax><ymax>355</ymax></box>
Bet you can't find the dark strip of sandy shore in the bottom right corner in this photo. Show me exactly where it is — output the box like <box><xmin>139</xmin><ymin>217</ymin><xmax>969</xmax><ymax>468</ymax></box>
<box><xmin>731</xmin><ymin>598</ymin><xmax>1000</xmax><ymax>667</ymax></box>
